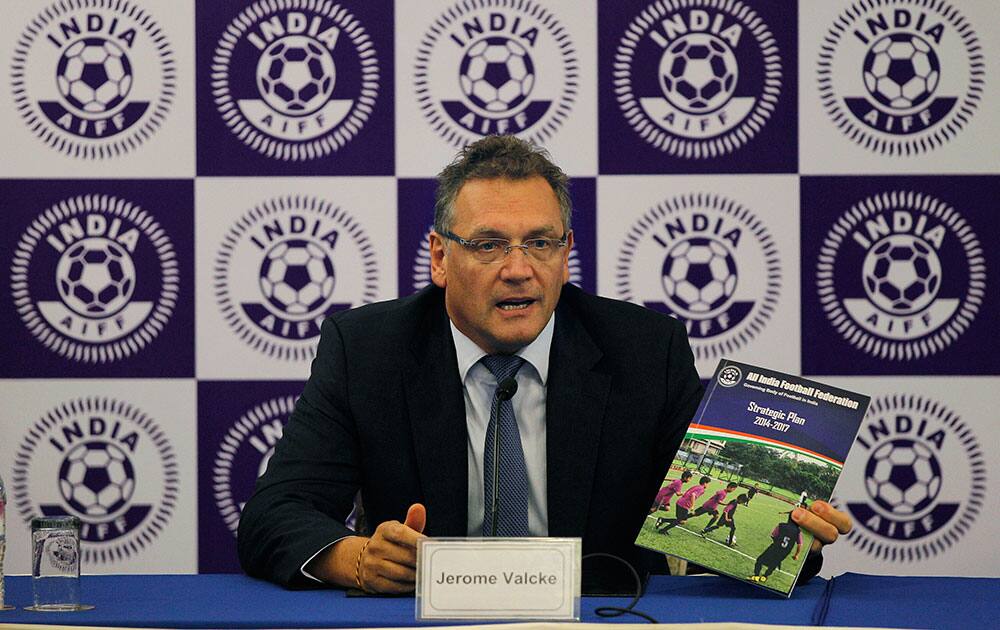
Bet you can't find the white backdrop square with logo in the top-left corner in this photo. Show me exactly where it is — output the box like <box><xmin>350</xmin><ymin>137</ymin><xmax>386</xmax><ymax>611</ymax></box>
<box><xmin>0</xmin><ymin>0</ymin><xmax>195</xmax><ymax>178</ymax></box>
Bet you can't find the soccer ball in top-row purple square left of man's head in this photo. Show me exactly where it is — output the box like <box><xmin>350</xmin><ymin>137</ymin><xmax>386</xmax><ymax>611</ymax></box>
<box><xmin>257</xmin><ymin>35</ymin><xmax>337</xmax><ymax>116</ymax></box>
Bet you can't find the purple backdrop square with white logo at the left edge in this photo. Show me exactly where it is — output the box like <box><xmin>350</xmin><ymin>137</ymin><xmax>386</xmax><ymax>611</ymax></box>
<box><xmin>0</xmin><ymin>180</ymin><xmax>194</xmax><ymax>378</ymax></box>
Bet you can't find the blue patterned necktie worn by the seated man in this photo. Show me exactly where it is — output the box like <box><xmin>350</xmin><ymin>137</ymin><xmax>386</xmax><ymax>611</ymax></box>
<box><xmin>481</xmin><ymin>354</ymin><xmax>528</xmax><ymax>536</ymax></box>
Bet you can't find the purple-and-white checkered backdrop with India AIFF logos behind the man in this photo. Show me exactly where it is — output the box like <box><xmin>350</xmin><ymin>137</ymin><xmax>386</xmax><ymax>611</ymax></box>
<box><xmin>0</xmin><ymin>0</ymin><xmax>1000</xmax><ymax>576</ymax></box>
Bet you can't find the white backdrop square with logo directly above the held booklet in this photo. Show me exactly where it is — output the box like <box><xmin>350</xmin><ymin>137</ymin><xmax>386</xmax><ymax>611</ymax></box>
<box><xmin>597</xmin><ymin>175</ymin><xmax>799</xmax><ymax>378</ymax></box>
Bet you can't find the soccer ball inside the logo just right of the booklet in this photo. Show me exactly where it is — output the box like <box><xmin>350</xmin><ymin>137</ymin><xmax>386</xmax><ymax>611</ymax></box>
<box><xmin>865</xmin><ymin>439</ymin><xmax>941</xmax><ymax>516</ymax></box>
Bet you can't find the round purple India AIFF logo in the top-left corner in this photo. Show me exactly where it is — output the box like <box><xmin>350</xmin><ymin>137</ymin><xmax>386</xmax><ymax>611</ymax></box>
<box><xmin>11</xmin><ymin>0</ymin><xmax>176</xmax><ymax>158</ymax></box>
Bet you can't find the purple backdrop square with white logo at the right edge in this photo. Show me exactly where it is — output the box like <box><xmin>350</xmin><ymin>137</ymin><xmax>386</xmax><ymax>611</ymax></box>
<box><xmin>801</xmin><ymin>176</ymin><xmax>1000</xmax><ymax>375</ymax></box>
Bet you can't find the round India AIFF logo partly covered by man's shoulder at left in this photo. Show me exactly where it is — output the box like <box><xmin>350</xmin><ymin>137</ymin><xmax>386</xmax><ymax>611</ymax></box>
<box><xmin>214</xmin><ymin>196</ymin><xmax>378</xmax><ymax>360</ymax></box>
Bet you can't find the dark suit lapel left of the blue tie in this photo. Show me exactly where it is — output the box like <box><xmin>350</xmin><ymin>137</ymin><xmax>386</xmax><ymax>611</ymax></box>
<box><xmin>404</xmin><ymin>300</ymin><xmax>469</xmax><ymax>536</ymax></box>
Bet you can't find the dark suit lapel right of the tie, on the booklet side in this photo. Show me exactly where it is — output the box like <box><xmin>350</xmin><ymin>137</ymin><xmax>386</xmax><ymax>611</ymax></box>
<box><xmin>545</xmin><ymin>302</ymin><xmax>611</xmax><ymax>536</ymax></box>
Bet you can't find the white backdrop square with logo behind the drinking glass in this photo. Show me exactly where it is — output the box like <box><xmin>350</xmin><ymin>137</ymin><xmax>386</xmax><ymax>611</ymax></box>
<box><xmin>0</xmin><ymin>379</ymin><xmax>198</xmax><ymax>574</ymax></box>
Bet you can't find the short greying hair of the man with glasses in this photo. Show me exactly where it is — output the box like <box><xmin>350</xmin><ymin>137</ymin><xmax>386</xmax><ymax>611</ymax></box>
<box><xmin>434</xmin><ymin>136</ymin><xmax>573</xmax><ymax>233</ymax></box>
